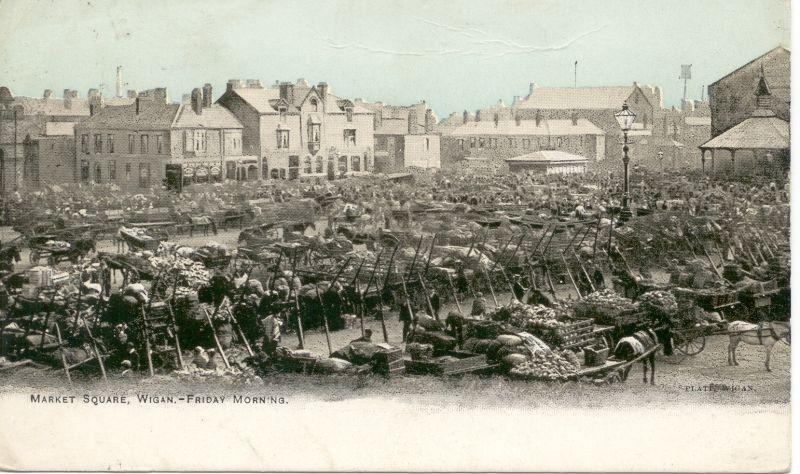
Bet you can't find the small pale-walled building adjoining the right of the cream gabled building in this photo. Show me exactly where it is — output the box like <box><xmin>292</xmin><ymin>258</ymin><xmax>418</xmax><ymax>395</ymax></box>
<box><xmin>355</xmin><ymin>99</ymin><xmax>441</xmax><ymax>173</ymax></box>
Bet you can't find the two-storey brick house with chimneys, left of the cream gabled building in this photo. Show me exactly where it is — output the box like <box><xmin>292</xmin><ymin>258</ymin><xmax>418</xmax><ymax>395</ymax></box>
<box><xmin>75</xmin><ymin>84</ymin><xmax>246</xmax><ymax>192</ymax></box>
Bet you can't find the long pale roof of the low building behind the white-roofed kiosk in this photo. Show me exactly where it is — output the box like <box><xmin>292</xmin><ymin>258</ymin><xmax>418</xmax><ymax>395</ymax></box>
<box><xmin>451</xmin><ymin>119</ymin><xmax>605</xmax><ymax>136</ymax></box>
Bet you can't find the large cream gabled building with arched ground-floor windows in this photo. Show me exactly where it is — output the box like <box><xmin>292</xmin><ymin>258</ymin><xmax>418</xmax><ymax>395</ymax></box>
<box><xmin>217</xmin><ymin>79</ymin><xmax>374</xmax><ymax>179</ymax></box>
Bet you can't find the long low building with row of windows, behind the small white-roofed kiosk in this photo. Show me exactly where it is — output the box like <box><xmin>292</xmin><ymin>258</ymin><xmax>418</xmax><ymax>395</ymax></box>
<box><xmin>442</xmin><ymin>116</ymin><xmax>606</xmax><ymax>171</ymax></box>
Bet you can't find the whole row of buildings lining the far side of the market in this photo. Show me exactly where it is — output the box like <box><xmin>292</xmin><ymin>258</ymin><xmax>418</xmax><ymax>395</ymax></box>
<box><xmin>0</xmin><ymin>47</ymin><xmax>790</xmax><ymax>192</ymax></box>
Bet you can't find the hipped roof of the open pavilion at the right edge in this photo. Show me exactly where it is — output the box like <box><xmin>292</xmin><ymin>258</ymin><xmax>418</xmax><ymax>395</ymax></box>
<box><xmin>700</xmin><ymin>116</ymin><xmax>789</xmax><ymax>150</ymax></box>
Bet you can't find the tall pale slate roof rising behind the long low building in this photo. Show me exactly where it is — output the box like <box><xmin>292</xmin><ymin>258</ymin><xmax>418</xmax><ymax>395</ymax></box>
<box><xmin>517</xmin><ymin>86</ymin><xmax>636</xmax><ymax>110</ymax></box>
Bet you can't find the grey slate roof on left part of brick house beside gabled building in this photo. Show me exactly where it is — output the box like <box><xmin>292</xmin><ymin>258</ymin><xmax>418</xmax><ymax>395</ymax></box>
<box><xmin>80</xmin><ymin>101</ymin><xmax>180</xmax><ymax>130</ymax></box>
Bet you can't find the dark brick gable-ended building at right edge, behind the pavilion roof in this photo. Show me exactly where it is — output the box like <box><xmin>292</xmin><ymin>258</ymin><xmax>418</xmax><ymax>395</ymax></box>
<box><xmin>708</xmin><ymin>46</ymin><xmax>791</xmax><ymax>137</ymax></box>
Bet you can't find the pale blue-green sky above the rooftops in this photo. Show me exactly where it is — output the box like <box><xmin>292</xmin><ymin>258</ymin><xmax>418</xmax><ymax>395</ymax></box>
<box><xmin>0</xmin><ymin>0</ymin><xmax>791</xmax><ymax>118</ymax></box>
